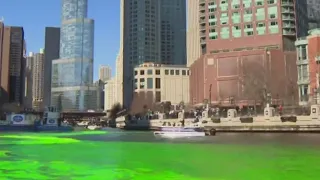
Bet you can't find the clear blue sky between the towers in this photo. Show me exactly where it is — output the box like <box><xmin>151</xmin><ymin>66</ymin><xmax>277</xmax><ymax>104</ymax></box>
<box><xmin>0</xmin><ymin>0</ymin><xmax>120</xmax><ymax>79</ymax></box>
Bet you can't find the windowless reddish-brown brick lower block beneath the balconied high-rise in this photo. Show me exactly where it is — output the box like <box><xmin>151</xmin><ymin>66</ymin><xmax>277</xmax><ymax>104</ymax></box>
<box><xmin>190</xmin><ymin>50</ymin><xmax>297</xmax><ymax>104</ymax></box>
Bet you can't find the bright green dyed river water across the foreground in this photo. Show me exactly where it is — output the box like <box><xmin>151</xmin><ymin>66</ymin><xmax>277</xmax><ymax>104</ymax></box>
<box><xmin>0</xmin><ymin>131</ymin><xmax>320</xmax><ymax>180</ymax></box>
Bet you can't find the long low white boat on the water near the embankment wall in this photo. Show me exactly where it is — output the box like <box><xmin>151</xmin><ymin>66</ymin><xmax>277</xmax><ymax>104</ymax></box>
<box><xmin>153</xmin><ymin>127</ymin><xmax>206</xmax><ymax>138</ymax></box>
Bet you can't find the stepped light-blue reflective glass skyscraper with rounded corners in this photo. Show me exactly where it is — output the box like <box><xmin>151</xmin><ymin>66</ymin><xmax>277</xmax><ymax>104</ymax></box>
<box><xmin>51</xmin><ymin>0</ymin><xmax>97</xmax><ymax>111</ymax></box>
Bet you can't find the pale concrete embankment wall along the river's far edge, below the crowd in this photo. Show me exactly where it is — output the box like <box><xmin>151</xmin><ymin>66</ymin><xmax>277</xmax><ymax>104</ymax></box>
<box><xmin>117</xmin><ymin>116</ymin><xmax>320</xmax><ymax>132</ymax></box>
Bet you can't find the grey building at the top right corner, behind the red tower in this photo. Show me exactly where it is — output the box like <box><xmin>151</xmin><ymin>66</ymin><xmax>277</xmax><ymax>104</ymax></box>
<box><xmin>306</xmin><ymin>0</ymin><xmax>320</xmax><ymax>30</ymax></box>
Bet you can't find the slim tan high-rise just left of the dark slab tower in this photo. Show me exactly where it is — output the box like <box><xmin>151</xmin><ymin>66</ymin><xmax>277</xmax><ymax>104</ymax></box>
<box><xmin>32</xmin><ymin>49</ymin><xmax>45</xmax><ymax>110</ymax></box>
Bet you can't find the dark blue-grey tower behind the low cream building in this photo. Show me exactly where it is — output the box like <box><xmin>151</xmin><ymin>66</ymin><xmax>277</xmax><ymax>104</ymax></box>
<box><xmin>120</xmin><ymin>0</ymin><xmax>186</xmax><ymax>107</ymax></box>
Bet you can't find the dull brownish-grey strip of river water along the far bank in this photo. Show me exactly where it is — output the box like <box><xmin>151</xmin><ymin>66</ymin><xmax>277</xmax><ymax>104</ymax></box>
<box><xmin>71</xmin><ymin>131</ymin><xmax>320</xmax><ymax>148</ymax></box>
